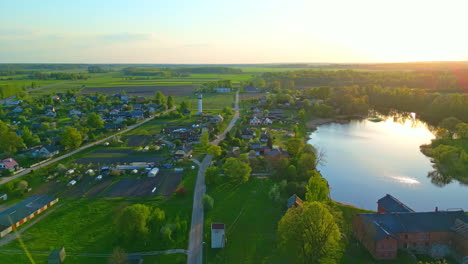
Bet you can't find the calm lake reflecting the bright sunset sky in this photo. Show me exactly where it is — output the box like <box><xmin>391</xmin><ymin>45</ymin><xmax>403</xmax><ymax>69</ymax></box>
<box><xmin>308</xmin><ymin>116</ymin><xmax>468</xmax><ymax>211</ymax></box>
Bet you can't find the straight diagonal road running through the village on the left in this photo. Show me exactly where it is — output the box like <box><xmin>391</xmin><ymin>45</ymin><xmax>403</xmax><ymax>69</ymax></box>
<box><xmin>0</xmin><ymin>108</ymin><xmax>175</xmax><ymax>185</ymax></box>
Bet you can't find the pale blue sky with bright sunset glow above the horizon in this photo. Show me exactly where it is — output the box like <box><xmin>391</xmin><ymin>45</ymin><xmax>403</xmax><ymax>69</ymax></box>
<box><xmin>0</xmin><ymin>0</ymin><xmax>468</xmax><ymax>64</ymax></box>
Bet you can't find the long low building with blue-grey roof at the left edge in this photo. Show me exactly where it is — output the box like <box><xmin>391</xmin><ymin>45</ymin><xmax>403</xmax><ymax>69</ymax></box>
<box><xmin>0</xmin><ymin>195</ymin><xmax>58</xmax><ymax>237</ymax></box>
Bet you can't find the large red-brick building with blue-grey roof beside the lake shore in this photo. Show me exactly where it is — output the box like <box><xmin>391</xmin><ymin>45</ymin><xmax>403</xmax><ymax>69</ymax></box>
<box><xmin>353</xmin><ymin>195</ymin><xmax>468</xmax><ymax>260</ymax></box>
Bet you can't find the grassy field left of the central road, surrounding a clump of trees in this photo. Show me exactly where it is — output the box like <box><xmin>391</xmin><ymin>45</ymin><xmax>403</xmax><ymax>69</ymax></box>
<box><xmin>0</xmin><ymin>167</ymin><xmax>196</xmax><ymax>258</ymax></box>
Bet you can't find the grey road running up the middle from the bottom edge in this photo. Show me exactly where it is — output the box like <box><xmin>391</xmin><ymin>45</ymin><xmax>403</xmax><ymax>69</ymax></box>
<box><xmin>187</xmin><ymin>92</ymin><xmax>239</xmax><ymax>264</ymax></box>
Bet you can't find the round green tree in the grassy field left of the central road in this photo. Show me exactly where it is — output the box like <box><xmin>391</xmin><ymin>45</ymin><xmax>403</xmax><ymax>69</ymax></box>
<box><xmin>116</xmin><ymin>204</ymin><xmax>151</xmax><ymax>240</ymax></box>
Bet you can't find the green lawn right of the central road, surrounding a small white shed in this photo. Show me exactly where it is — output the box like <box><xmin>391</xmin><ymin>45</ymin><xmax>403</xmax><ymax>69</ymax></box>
<box><xmin>204</xmin><ymin>178</ymin><xmax>285</xmax><ymax>263</ymax></box>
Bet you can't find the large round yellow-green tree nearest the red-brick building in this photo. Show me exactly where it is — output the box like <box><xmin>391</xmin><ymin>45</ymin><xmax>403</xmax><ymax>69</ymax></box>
<box><xmin>278</xmin><ymin>202</ymin><xmax>340</xmax><ymax>263</ymax></box>
